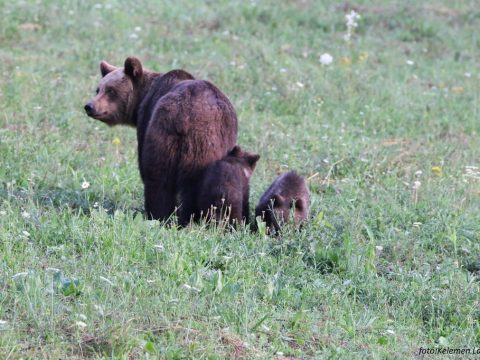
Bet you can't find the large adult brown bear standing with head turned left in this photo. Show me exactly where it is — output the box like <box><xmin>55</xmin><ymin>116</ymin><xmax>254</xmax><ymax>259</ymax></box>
<box><xmin>85</xmin><ymin>57</ymin><xmax>237</xmax><ymax>226</ymax></box>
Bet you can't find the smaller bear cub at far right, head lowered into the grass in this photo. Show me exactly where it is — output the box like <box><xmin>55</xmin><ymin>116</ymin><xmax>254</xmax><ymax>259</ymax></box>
<box><xmin>255</xmin><ymin>171</ymin><xmax>310</xmax><ymax>233</ymax></box>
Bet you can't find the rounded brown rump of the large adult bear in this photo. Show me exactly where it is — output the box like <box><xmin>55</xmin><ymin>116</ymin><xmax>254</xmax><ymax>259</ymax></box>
<box><xmin>145</xmin><ymin>81</ymin><xmax>237</xmax><ymax>172</ymax></box>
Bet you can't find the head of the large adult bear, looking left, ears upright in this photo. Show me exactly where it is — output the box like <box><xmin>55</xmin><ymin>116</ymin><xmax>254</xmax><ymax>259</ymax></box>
<box><xmin>85</xmin><ymin>57</ymin><xmax>144</xmax><ymax>126</ymax></box>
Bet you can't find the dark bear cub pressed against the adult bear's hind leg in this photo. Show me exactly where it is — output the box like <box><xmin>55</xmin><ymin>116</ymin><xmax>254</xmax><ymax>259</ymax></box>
<box><xmin>197</xmin><ymin>145</ymin><xmax>260</xmax><ymax>226</ymax></box>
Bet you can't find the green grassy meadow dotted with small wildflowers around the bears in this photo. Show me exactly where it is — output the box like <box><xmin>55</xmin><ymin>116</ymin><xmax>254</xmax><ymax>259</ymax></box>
<box><xmin>0</xmin><ymin>0</ymin><xmax>480</xmax><ymax>359</ymax></box>
